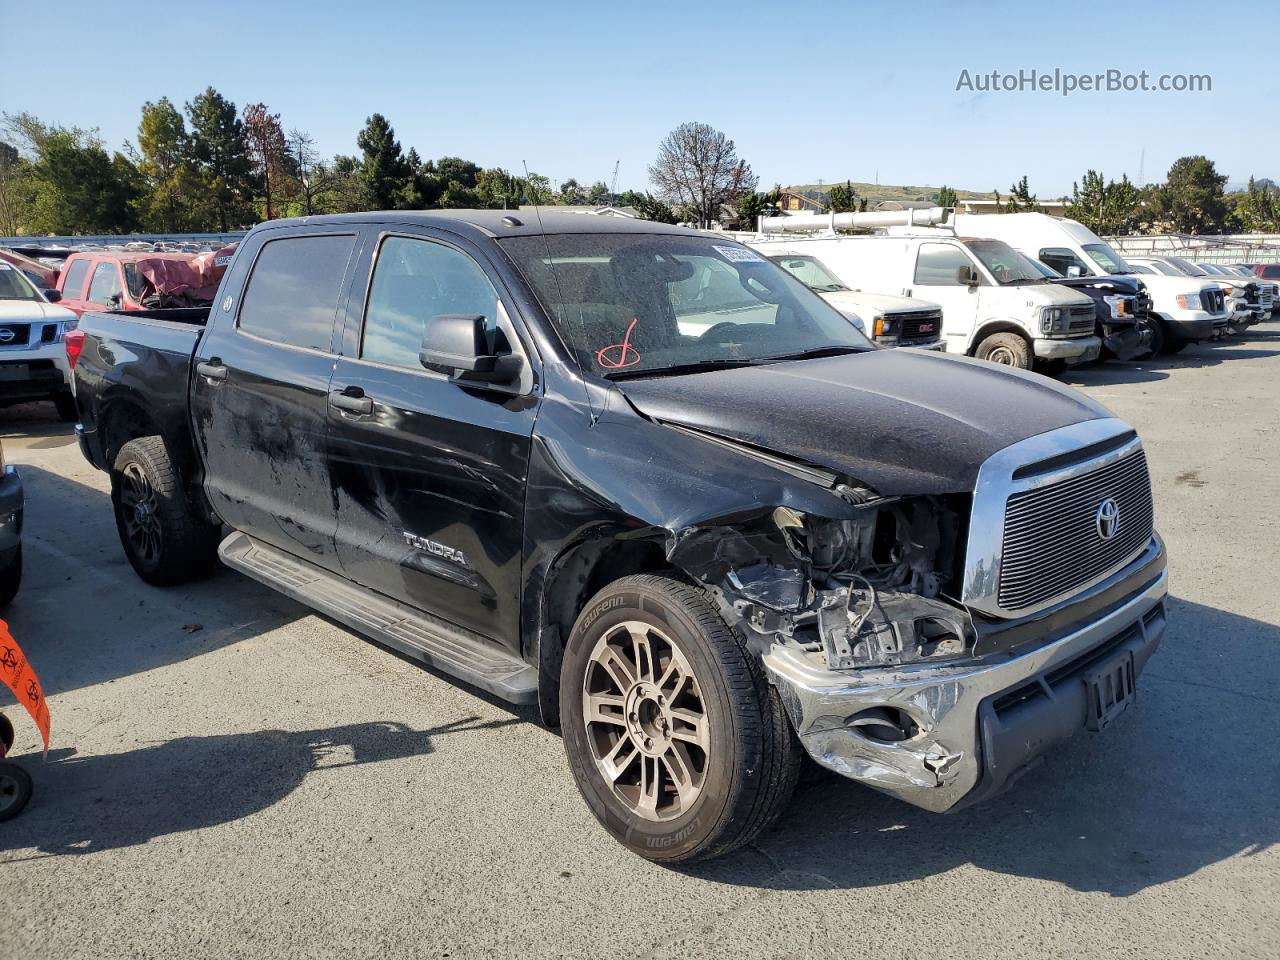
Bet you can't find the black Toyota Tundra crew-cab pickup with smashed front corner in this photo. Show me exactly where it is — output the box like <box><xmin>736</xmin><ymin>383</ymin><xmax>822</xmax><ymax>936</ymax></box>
<box><xmin>72</xmin><ymin>211</ymin><xmax>1167</xmax><ymax>861</ymax></box>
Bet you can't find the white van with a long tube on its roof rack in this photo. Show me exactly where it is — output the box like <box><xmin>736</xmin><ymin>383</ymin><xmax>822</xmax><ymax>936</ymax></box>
<box><xmin>748</xmin><ymin>232</ymin><xmax>1102</xmax><ymax>370</ymax></box>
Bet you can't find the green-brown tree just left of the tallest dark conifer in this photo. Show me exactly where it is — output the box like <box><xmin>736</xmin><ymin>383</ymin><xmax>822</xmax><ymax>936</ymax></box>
<box><xmin>136</xmin><ymin>97</ymin><xmax>207</xmax><ymax>233</ymax></box>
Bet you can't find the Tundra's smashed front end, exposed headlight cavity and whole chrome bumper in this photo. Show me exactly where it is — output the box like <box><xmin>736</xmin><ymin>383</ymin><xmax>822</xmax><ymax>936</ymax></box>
<box><xmin>667</xmin><ymin>435</ymin><xmax>1167</xmax><ymax>813</ymax></box>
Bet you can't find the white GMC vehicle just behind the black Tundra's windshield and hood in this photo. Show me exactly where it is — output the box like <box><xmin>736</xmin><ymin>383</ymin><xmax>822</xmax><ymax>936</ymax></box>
<box><xmin>769</xmin><ymin>247</ymin><xmax>946</xmax><ymax>351</ymax></box>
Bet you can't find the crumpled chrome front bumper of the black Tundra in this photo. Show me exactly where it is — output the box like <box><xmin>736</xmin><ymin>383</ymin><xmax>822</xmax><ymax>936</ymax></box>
<box><xmin>764</xmin><ymin>538</ymin><xmax>1169</xmax><ymax>813</ymax></box>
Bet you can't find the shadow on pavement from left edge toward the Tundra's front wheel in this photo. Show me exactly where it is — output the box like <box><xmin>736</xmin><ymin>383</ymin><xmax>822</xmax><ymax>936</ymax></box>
<box><xmin>0</xmin><ymin>717</ymin><xmax>524</xmax><ymax>863</ymax></box>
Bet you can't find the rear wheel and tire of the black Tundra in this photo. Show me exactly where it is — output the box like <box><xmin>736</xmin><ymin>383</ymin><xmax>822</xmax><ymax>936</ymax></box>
<box><xmin>111</xmin><ymin>436</ymin><xmax>220</xmax><ymax>586</ymax></box>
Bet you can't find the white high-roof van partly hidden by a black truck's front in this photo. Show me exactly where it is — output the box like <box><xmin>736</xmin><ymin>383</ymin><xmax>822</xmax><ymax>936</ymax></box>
<box><xmin>955</xmin><ymin>214</ymin><xmax>1230</xmax><ymax>353</ymax></box>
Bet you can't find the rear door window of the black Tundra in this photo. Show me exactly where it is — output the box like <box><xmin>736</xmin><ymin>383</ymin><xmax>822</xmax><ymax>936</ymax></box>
<box><xmin>239</xmin><ymin>234</ymin><xmax>356</xmax><ymax>351</ymax></box>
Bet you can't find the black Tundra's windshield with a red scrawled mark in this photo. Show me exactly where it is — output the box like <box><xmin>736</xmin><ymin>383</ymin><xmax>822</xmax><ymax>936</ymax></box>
<box><xmin>500</xmin><ymin>233</ymin><xmax>874</xmax><ymax>378</ymax></box>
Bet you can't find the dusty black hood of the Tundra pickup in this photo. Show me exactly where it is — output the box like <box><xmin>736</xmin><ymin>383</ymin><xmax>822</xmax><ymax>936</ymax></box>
<box><xmin>618</xmin><ymin>349</ymin><xmax>1111</xmax><ymax>495</ymax></box>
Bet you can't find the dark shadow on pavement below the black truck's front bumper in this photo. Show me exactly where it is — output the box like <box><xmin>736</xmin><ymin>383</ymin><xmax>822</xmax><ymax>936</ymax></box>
<box><xmin>689</xmin><ymin>600</ymin><xmax>1280</xmax><ymax>896</ymax></box>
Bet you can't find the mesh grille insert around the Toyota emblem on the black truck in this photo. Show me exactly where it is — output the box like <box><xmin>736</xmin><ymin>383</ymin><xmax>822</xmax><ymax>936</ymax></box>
<box><xmin>997</xmin><ymin>448</ymin><xmax>1155</xmax><ymax>612</ymax></box>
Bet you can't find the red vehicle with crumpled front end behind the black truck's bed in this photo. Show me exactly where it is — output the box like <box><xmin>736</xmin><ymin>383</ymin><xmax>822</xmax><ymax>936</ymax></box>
<box><xmin>58</xmin><ymin>251</ymin><xmax>230</xmax><ymax>316</ymax></box>
